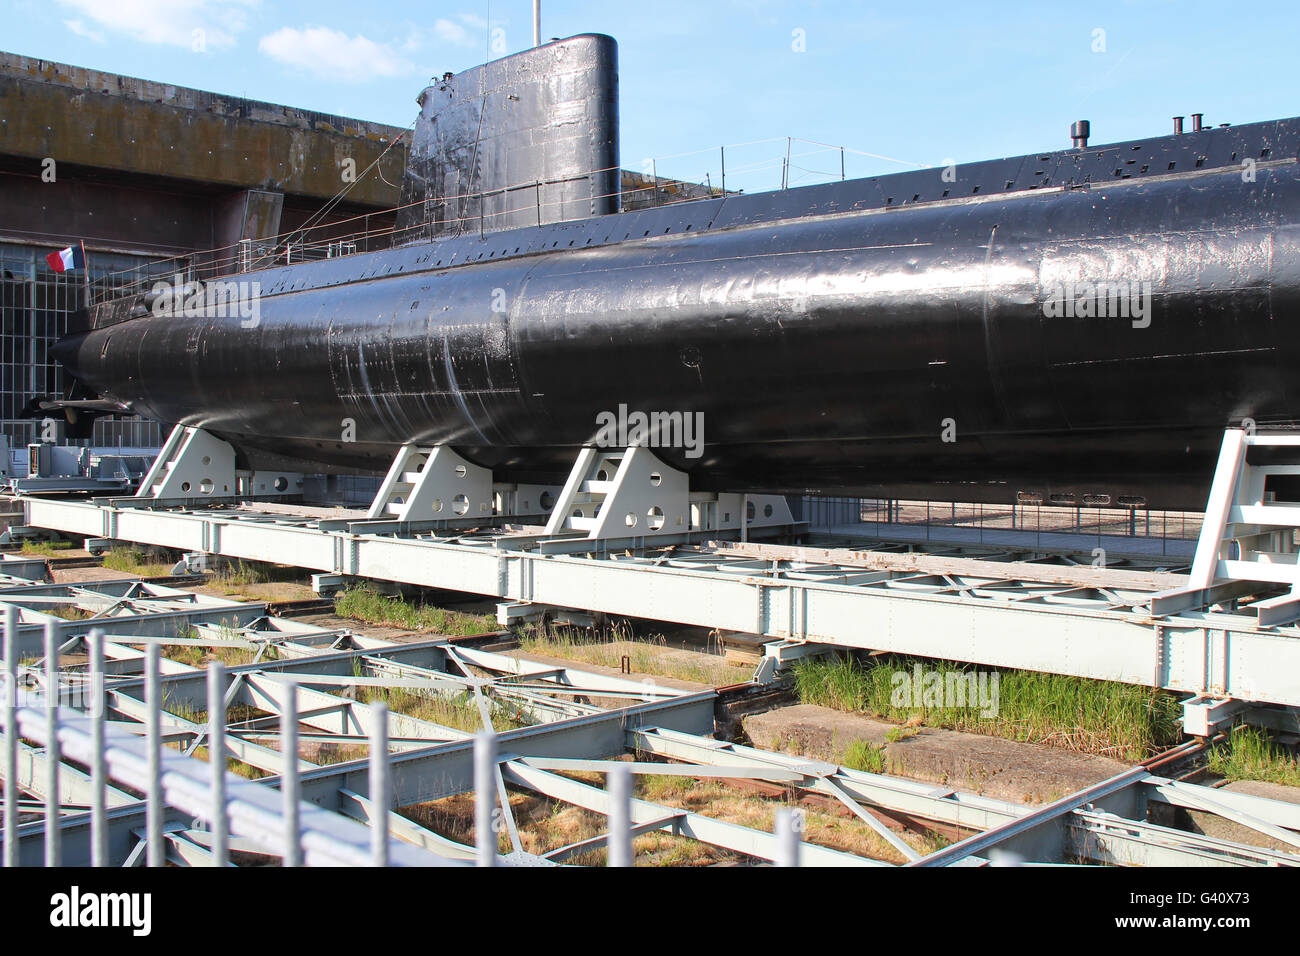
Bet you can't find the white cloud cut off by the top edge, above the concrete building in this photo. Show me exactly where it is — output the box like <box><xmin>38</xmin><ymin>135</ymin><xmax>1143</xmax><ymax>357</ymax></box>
<box><xmin>59</xmin><ymin>0</ymin><xmax>259</xmax><ymax>49</ymax></box>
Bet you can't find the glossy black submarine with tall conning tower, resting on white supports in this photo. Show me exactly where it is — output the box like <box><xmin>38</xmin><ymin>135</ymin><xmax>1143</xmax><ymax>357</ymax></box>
<box><xmin>47</xmin><ymin>35</ymin><xmax>1300</xmax><ymax>509</ymax></box>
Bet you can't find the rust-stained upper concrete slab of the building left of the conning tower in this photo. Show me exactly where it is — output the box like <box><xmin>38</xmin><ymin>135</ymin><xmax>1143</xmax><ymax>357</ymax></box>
<box><xmin>0</xmin><ymin>52</ymin><xmax>406</xmax><ymax>208</ymax></box>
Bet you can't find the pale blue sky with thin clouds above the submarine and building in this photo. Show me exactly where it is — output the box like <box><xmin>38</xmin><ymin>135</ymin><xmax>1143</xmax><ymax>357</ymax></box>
<box><xmin>0</xmin><ymin>0</ymin><xmax>1300</xmax><ymax>190</ymax></box>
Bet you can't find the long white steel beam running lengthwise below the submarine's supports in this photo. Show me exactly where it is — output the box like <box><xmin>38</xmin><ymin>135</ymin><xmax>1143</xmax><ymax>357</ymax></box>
<box><xmin>25</xmin><ymin>498</ymin><xmax>1300</xmax><ymax>706</ymax></box>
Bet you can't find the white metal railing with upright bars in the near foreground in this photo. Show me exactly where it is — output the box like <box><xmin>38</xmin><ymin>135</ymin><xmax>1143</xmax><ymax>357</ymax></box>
<box><xmin>0</xmin><ymin>605</ymin><xmax>743</xmax><ymax>866</ymax></box>
